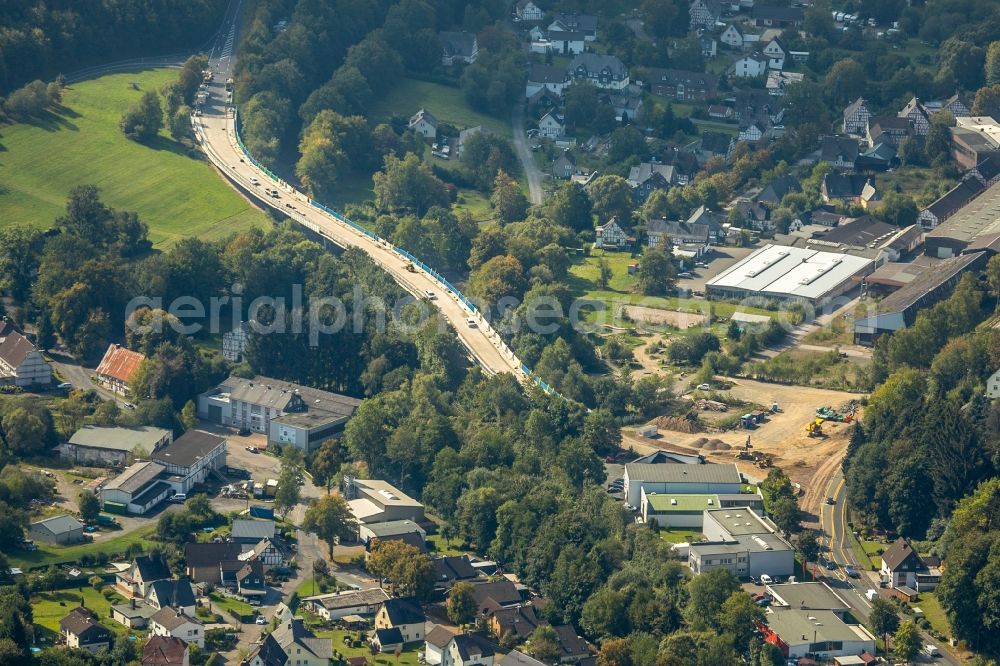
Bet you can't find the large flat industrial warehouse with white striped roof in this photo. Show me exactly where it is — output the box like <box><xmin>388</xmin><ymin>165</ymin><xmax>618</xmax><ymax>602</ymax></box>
<box><xmin>705</xmin><ymin>245</ymin><xmax>875</xmax><ymax>304</ymax></box>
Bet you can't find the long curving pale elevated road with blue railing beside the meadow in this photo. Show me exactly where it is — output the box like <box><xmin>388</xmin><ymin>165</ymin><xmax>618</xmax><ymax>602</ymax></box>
<box><xmin>193</xmin><ymin>0</ymin><xmax>530</xmax><ymax>383</ymax></box>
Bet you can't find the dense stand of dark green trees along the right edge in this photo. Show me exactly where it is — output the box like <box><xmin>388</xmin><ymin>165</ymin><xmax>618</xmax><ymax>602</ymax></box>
<box><xmin>844</xmin><ymin>264</ymin><xmax>1000</xmax><ymax>656</ymax></box>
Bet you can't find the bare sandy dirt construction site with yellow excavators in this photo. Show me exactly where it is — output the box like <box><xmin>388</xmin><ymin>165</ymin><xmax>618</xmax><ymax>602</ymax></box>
<box><xmin>623</xmin><ymin>379</ymin><xmax>862</xmax><ymax>523</ymax></box>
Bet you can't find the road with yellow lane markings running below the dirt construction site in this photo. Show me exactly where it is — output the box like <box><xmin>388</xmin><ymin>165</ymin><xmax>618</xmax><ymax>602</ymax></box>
<box><xmin>817</xmin><ymin>471</ymin><xmax>962</xmax><ymax>666</ymax></box>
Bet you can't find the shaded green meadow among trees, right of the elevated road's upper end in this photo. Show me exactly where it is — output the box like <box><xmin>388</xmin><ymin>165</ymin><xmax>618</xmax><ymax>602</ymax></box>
<box><xmin>368</xmin><ymin>79</ymin><xmax>511</xmax><ymax>138</ymax></box>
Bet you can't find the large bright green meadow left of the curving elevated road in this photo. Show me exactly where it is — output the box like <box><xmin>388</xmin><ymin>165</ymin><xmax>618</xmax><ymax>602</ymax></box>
<box><xmin>0</xmin><ymin>69</ymin><xmax>270</xmax><ymax>247</ymax></box>
